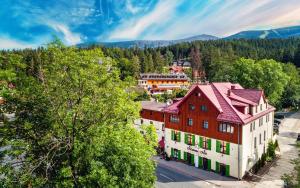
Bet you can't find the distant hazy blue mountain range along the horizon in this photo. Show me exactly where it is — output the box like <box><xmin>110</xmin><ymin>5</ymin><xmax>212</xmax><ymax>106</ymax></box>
<box><xmin>78</xmin><ymin>26</ymin><xmax>300</xmax><ymax>48</ymax></box>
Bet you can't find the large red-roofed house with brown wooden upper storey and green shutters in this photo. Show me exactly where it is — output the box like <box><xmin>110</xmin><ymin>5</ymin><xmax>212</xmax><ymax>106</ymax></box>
<box><xmin>141</xmin><ymin>82</ymin><xmax>275</xmax><ymax>179</ymax></box>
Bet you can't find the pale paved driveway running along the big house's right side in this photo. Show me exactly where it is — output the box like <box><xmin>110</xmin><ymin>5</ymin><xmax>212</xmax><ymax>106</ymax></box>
<box><xmin>256</xmin><ymin>112</ymin><xmax>300</xmax><ymax>188</ymax></box>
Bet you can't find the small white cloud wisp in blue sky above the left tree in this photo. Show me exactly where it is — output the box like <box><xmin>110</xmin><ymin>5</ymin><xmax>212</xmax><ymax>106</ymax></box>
<box><xmin>48</xmin><ymin>22</ymin><xmax>82</xmax><ymax>45</ymax></box>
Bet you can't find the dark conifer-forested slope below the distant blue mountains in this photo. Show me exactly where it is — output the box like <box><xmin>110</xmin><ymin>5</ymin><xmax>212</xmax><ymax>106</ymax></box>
<box><xmin>100</xmin><ymin>38</ymin><xmax>300</xmax><ymax>69</ymax></box>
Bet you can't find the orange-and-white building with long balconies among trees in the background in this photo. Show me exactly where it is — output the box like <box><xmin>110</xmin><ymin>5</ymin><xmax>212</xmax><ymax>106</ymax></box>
<box><xmin>138</xmin><ymin>73</ymin><xmax>189</xmax><ymax>94</ymax></box>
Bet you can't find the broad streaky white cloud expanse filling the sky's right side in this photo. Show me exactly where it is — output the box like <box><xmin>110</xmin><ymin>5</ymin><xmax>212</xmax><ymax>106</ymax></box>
<box><xmin>109</xmin><ymin>0</ymin><xmax>300</xmax><ymax>40</ymax></box>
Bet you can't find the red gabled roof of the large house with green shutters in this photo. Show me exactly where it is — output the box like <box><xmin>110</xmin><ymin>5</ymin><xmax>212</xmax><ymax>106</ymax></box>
<box><xmin>163</xmin><ymin>82</ymin><xmax>275</xmax><ymax>124</ymax></box>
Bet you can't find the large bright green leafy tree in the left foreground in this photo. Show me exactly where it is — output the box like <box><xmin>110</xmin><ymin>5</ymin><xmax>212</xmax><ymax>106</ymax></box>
<box><xmin>0</xmin><ymin>44</ymin><xmax>155</xmax><ymax>187</ymax></box>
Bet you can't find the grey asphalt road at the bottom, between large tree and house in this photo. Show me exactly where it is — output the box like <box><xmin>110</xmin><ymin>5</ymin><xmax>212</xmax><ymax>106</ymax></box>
<box><xmin>156</xmin><ymin>163</ymin><xmax>214</xmax><ymax>188</ymax></box>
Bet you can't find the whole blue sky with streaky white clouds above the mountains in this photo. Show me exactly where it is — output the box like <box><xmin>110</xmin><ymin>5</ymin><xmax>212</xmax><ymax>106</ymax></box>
<box><xmin>0</xmin><ymin>0</ymin><xmax>300</xmax><ymax>49</ymax></box>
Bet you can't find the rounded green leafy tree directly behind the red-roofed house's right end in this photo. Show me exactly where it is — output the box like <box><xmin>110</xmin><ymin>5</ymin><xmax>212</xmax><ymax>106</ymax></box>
<box><xmin>228</xmin><ymin>58</ymin><xmax>289</xmax><ymax>105</ymax></box>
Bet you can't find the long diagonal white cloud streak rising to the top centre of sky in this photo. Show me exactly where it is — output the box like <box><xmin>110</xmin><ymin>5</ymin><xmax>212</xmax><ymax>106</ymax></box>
<box><xmin>109</xmin><ymin>0</ymin><xmax>180</xmax><ymax>40</ymax></box>
